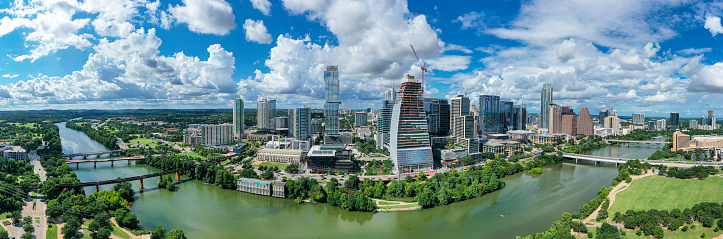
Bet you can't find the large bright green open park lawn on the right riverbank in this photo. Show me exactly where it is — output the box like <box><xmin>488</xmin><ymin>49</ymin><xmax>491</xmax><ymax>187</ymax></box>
<box><xmin>608</xmin><ymin>175</ymin><xmax>723</xmax><ymax>215</ymax></box>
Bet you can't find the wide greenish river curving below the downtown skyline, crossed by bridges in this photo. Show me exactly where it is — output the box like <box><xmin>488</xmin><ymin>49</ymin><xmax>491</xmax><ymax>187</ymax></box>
<box><xmin>58</xmin><ymin>123</ymin><xmax>652</xmax><ymax>238</ymax></box>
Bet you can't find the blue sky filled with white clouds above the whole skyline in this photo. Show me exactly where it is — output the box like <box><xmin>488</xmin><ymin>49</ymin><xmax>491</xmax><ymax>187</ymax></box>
<box><xmin>0</xmin><ymin>0</ymin><xmax>723</xmax><ymax>117</ymax></box>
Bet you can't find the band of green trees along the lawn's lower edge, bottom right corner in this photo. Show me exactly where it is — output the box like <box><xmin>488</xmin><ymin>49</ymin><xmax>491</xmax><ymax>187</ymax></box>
<box><xmin>612</xmin><ymin>202</ymin><xmax>723</xmax><ymax>238</ymax></box>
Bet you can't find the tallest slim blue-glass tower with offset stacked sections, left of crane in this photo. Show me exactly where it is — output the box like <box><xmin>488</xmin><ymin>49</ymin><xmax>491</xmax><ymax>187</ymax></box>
<box><xmin>324</xmin><ymin>66</ymin><xmax>341</xmax><ymax>136</ymax></box>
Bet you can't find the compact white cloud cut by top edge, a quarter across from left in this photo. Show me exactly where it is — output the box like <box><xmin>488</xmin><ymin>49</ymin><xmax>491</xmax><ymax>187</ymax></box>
<box><xmin>164</xmin><ymin>0</ymin><xmax>236</xmax><ymax>35</ymax></box>
